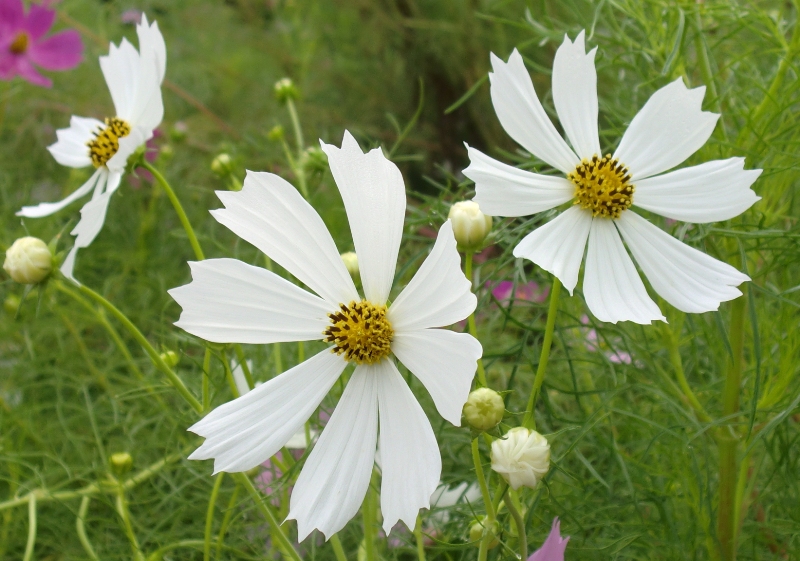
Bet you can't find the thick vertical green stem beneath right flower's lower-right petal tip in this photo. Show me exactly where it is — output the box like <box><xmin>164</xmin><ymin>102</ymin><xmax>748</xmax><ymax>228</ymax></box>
<box><xmin>717</xmin><ymin>295</ymin><xmax>746</xmax><ymax>561</ymax></box>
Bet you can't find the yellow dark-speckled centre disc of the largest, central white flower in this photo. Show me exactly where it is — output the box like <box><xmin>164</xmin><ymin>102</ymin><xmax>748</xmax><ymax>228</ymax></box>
<box><xmin>322</xmin><ymin>300</ymin><xmax>394</xmax><ymax>364</ymax></box>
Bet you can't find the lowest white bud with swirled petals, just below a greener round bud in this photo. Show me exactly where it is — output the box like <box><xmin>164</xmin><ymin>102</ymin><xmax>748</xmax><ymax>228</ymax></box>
<box><xmin>492</xmin><ymin>427</ymin><xmax>550</xmax><ymax>490</ymax></box>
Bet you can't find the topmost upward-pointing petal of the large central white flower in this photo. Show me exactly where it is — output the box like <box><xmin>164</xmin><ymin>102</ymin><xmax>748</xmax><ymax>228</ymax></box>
<box><xmin>320</xmin><ymin>131</ymin><xmax>406</xmax><ymax>304</ymax></box>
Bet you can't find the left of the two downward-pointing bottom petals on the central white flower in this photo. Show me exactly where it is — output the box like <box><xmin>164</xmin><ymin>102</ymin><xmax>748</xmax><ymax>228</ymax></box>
<box><xmin>287</xmin><ymin>365</ymin><xmax>378</xmax><ymax>541</ymax></box>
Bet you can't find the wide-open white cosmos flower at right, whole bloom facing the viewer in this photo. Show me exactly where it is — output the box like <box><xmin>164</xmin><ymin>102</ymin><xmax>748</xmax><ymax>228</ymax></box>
<box><xmin>464</xmin><ymin>32</ymin><xmax>761</xmax><ymax>324</ymax></box>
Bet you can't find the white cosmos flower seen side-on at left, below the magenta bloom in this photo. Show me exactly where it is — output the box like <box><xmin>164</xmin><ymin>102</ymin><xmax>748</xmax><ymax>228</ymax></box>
<box><xmin>17</xmin><ymin>15</ymin><xmax>167</xmax><ymax>280</ymax></box>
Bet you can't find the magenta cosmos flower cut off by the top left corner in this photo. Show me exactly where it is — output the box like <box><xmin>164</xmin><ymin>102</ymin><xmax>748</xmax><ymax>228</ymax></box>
<box><xmin>0</xmin><ymin>0</ymin><xmax>83</xmax><ymax>88</ymax></box>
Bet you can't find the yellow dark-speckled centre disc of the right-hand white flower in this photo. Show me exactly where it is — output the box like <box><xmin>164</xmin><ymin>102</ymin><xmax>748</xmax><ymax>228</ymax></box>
<box><xmin>567</xmin><ymin>154</ymin><xmax>635</xmax><ymax>218</ymax></box>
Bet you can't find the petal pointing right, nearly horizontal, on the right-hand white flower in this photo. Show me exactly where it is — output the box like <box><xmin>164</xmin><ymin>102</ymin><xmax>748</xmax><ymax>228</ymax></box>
<box><xmin>633</xmin><ymin>158</ymin><xmax>761</xmax><ymax>224</ymax></box>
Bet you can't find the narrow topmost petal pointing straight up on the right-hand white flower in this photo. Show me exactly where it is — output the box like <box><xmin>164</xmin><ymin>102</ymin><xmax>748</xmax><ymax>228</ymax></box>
<box><xmin>553</xmin><ymin>31</ymin><xmax>602</xmax><ymax>159</ymax></box>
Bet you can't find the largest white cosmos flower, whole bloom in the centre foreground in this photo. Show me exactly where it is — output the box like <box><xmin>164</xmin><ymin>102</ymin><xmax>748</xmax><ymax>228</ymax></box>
<box><xmin>170</xmin><ymin>132</ymin><xmax>482</xmax><ymax>540</ymax></box>
